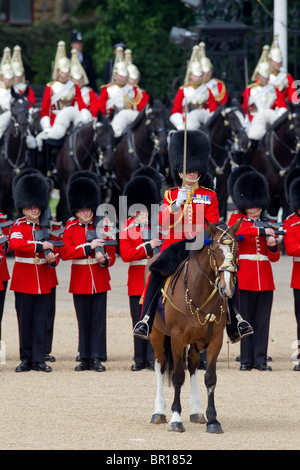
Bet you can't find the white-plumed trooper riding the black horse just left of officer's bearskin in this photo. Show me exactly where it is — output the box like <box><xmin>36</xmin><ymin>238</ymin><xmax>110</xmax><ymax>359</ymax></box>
<box><xmin>99</xmin><ymin>47</ymin><xmax>148</xmax><ymax>138</ymax></box>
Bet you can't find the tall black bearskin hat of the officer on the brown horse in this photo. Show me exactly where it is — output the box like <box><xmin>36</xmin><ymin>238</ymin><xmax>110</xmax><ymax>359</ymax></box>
<box><xmin>169</xmin><ymin>130</ymin><xmax>210</xmax><ymax>185</ymax></box>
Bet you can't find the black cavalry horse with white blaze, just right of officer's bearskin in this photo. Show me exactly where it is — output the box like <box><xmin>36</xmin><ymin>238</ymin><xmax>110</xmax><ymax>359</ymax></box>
<box><xmin>202</xmin><ymin>100</ymin><xmax>249</xmax><ymax>222</ymax></box>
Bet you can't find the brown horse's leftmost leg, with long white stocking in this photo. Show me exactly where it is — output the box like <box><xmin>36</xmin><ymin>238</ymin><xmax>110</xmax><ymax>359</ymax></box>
<box><xmin>150</xmin><ymin>327</ymin><xmax>167</xmax><ymax>424</ymax></box>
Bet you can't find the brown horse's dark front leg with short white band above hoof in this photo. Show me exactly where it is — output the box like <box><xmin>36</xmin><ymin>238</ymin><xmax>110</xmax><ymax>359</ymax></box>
<box><xmin>169</xmin><ymin>339</ymin><xmax>185</xmax><ymax>432</ymax></box>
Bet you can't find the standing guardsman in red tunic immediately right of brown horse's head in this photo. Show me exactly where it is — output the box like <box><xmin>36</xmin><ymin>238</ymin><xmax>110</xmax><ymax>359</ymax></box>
<box><xmin>228</xmin><ymin>167</ymin><xmax>280</xmax><ymax>371</ymax></box>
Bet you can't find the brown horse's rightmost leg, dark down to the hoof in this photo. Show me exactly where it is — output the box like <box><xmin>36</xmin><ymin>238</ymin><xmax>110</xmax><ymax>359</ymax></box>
<box><xmin>204</xmin><ymin>354</ymin><xmax>223</xmax><ymax>434</ymax></box>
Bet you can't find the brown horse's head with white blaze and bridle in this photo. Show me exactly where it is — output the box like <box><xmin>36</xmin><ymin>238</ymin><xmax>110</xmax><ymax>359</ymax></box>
<box><xmin>206</xmin><ymin>219</ymin><xmax>242</xmax><ymax>298</ymax></box>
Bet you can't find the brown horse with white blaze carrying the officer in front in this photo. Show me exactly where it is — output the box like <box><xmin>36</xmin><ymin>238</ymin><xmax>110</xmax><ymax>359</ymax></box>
<box><xmin>150</xmin><ymin>219</ymin><xmax>242</xmax><ymax>433</ymax></box>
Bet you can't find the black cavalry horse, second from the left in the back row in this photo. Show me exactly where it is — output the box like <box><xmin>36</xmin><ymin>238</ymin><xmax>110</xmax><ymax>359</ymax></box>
<box><xmin>55</xmin><ymin>112</ymin><xmax>115</xmax><ymax>224</ymax></box>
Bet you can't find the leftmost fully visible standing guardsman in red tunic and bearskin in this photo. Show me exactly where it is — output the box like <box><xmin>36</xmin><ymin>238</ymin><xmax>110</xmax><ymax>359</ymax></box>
<box><xmin>10</xmin><ymin>170</ymin><xmax>56</xmax><ymax>372</ymax></box>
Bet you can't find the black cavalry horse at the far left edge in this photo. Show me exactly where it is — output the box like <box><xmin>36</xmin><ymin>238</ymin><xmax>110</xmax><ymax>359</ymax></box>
<box><xmin>0</xmin><ymin>88</ymin><xmax>30</xmax><ymax>218</ymax></box>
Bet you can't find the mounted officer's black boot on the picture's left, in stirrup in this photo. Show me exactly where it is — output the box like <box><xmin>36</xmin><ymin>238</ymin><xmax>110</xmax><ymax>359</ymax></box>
<box><xmin>132</xmin><ymin>271</ymin><xmax>166</xmax><ymax>339</ymax></box>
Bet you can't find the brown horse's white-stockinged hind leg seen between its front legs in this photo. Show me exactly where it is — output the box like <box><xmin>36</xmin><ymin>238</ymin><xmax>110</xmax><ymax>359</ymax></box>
<box><xmin>188</xmin><ymin>347</ymin><xmax>206</xmax><ymax>424</ymax></box>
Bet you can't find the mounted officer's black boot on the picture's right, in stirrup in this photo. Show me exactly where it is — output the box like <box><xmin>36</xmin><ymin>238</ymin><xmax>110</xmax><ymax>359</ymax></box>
<box><xmin>226</xmin><ymin>282</ymin><xmax>253</xmax><ymax>343</ymax></box>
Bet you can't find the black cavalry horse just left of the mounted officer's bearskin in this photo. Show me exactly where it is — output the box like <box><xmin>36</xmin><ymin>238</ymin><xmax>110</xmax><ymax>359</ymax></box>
<box><xmin>114</xmin><ymin>97</ymin><xmax>169</xmax><ymax>194</ymax></box>
